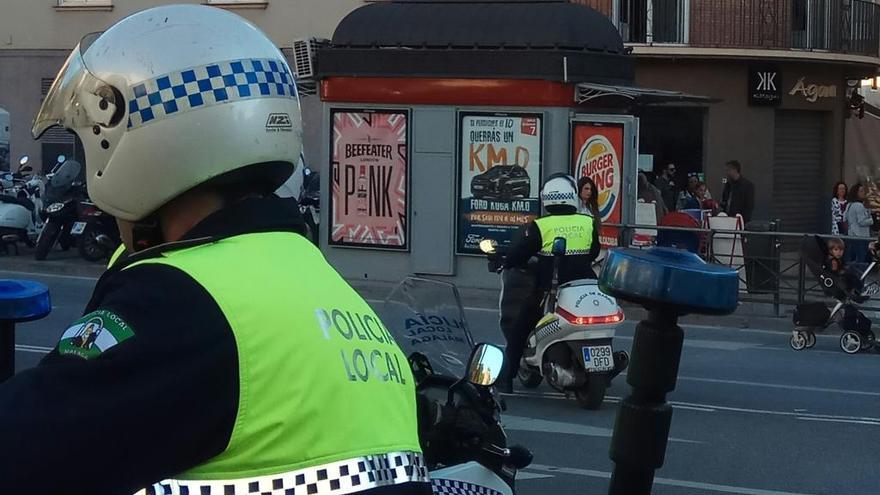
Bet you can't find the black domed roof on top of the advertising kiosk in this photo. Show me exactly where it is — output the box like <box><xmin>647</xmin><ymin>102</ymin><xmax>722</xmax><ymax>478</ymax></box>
<box><xmin>316</xmin><ymin>0</ymin><xmax>635</xmax><ymax>84</ymax></box>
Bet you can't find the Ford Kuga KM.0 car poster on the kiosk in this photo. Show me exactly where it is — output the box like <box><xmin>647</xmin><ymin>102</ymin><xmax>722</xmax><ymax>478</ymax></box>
<box><xmin>456</xmin><ymin>113</ymin><xmax>543</xmax><ymax>254</ymax></box>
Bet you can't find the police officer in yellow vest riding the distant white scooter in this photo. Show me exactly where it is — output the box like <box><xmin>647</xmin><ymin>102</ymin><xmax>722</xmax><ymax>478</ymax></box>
<box><xmin>499</xmin><ymin>174</ymin><xmax>601</xmax><ymax>393</ymax></box>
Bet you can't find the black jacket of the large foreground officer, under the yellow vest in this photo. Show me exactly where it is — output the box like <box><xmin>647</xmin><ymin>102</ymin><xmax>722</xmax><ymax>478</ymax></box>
<box><xmin>0</xmin><ymin>198</ymin><xmax>430</xmax><ymax>495</ymax></box>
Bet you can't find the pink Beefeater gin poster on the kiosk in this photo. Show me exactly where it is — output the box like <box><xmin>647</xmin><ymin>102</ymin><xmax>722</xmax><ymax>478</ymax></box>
<box><xmin>330</xmin><ymin>110</ymin><xmax>409</xmax><ymax>249</ymax></box>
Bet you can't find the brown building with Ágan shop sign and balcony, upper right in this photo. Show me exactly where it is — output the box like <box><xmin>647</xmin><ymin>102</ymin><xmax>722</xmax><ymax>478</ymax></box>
<box><xmin>579</xmin><ymin>0</ymin><xmax>880</xmax><ymax>232</ymax></box>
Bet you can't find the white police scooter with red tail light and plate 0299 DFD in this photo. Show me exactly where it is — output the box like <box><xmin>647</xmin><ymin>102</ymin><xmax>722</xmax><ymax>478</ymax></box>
<box><xmin>480</xmin><ymin>237</ymin><xmax>629</xmax><ymax>410</ymax></box>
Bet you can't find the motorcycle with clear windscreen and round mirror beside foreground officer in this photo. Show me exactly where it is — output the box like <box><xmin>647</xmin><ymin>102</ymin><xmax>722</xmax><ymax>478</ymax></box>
<box><xmin>380</xmin><ymin>277</ymin><xmax>532</xmax><ymax>495</ymax></box>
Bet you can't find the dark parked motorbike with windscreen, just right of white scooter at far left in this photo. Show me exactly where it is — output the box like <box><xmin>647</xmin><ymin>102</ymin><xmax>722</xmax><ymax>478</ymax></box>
<box><xmin>34</xmin><ymin>160</ymin><xmax>85</xmax><ymax>261</ymax></box>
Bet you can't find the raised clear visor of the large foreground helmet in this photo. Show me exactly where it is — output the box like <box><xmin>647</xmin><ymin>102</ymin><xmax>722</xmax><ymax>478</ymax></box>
<box><xmin>31</xmin><ymin>33</ymin><xmax>115</xmax><ymax>139</ymax></box>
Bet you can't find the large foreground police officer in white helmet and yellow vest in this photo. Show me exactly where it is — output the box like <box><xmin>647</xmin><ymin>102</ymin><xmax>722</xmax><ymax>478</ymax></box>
<box><xmin>0</xmin><ymin>5</ymin><xmax>431</xmax><ymax>495</ymax></box>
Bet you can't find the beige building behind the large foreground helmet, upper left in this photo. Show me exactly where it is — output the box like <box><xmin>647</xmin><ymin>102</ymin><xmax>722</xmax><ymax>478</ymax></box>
<box><xmin>0</xmin><ymin>0</ymin><xmax>363</xmax><ymax>169</ymax></box>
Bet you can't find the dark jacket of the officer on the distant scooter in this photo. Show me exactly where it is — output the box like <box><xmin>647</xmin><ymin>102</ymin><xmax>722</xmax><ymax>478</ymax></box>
<box><xmin>504</xmin><ymin>213</ymin><xmax>602</xmax><ymax>289</ymax></box>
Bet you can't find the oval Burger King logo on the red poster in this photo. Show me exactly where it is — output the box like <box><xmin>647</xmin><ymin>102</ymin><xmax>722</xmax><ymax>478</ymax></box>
<box><xmin>575</xmin><ymin>134</ymin><xmax>622</xmax><ymax>221</ymax></box>
